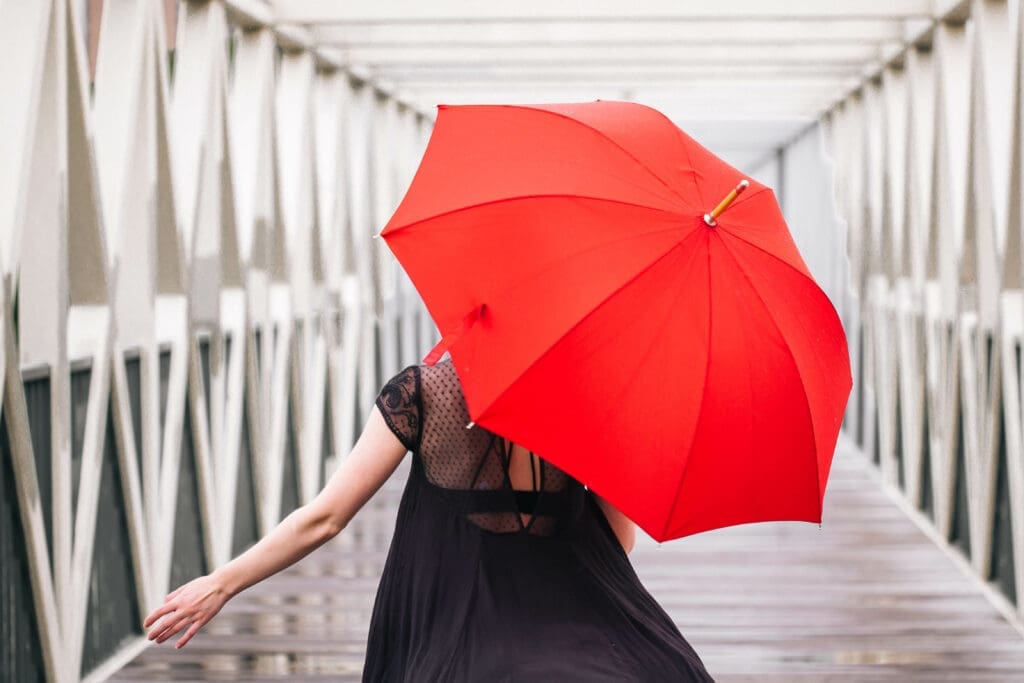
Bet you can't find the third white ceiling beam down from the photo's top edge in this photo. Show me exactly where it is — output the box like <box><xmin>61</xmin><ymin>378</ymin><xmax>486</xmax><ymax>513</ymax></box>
<box><xmin>340</xmin><ymin>43</ymin><xmax>887</xmax><ymax>68</ymax></box>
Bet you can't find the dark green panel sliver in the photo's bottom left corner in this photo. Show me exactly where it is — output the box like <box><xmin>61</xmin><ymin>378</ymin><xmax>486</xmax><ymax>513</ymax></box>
<box><xmin>0</xmin><ymin>409</ymin><xmax>49</xmax><ymax>683</ymax></box>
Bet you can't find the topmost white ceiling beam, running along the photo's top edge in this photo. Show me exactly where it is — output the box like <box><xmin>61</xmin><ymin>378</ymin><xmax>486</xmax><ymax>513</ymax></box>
<box><xmin>271</xmin><ymin>0</ymin><xmax>934</xmax><ymax>24</ymax></box>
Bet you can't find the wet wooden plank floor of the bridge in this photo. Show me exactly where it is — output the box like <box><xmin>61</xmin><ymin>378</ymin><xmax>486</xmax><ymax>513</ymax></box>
<box><xmin>114</xmin><ymin>440</ymin><xmax>1024</xmax><ymax>683</ymax></box>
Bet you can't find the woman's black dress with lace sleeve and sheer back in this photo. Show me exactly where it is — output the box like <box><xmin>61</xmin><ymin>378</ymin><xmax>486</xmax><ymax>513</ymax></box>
<box><xmin>362</xmin><ymin>360</ymin><xmax>712</xmax><ymax>683</ymax></box>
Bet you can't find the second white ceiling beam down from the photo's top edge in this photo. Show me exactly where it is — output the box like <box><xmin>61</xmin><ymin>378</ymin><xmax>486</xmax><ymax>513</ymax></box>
<box><xmin>311</xmin><ymin>18</ymin><xmax>905</xmax><ymax>48</ymax></box>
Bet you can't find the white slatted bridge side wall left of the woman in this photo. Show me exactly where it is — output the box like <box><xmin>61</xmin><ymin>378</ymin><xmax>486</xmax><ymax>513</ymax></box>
<box><xmin>0</xmin><ymin>0</ymin><xmax>435</xmax><ymax>682</ymax></box>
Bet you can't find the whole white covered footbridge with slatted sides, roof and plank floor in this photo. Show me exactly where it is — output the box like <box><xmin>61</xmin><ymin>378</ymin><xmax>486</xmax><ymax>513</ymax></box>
<box><xmin>0</xmin><ymin>0</ymin><xmax>1024</xmax><ymax>683</ymax></box>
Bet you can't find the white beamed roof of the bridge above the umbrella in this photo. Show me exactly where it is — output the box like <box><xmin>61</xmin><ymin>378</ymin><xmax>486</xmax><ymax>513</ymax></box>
<box><xmin>251</xmin><ymin>0</ymin><xmax>966</xmax><ymax>164</ymax></box>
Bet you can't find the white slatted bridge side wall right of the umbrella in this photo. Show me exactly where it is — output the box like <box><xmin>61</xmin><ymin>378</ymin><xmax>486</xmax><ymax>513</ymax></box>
<box><xmin>822</xmin><ymin>0</ymin><xmax>1024</xmax><ymax>625</ymax></box>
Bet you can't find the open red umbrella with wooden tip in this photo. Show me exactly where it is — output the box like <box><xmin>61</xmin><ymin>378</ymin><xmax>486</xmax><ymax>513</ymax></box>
<box><xmin>381</xmin><ymin>101</ymin><xmax>851</xmax><ymax>541</ymax></box>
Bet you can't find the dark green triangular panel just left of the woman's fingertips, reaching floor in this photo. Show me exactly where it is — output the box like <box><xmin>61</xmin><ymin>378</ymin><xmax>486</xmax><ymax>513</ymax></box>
<box><xmin>82</xmin><ymin>397</ymin><xmax>142</xmax><ymax>676</ymax></box>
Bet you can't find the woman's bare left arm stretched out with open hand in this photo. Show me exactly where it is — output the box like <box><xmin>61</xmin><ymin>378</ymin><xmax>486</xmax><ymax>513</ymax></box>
<box><xmin>143</xmin><ymin>405</ymin><xmax>406</xmax><ymax>647</ymax></box>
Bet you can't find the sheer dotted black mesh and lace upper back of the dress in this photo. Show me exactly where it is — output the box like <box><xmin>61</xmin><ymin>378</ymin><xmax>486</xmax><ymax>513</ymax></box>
<box><xmin>377</xmin><ymin>359</ymin><xmax>582</xmax><ymax>536</ymax></box>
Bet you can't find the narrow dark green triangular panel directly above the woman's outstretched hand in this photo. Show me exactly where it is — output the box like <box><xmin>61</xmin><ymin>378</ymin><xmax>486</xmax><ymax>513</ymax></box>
<box><xmin>171</xmin><ymin>393</ymin><xmax>207</xmax><ymax>589</ymax></box>
